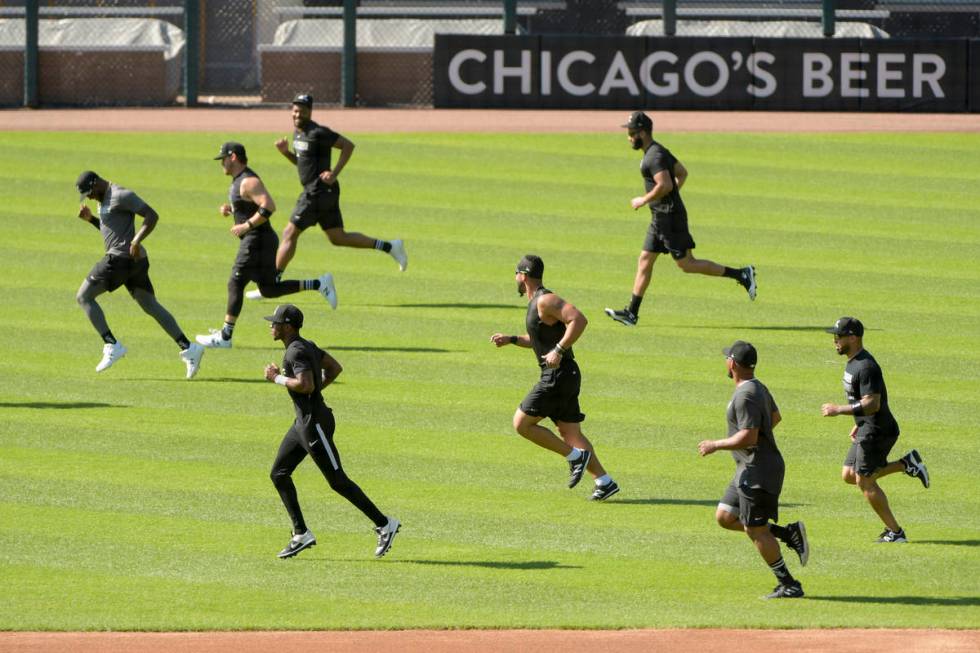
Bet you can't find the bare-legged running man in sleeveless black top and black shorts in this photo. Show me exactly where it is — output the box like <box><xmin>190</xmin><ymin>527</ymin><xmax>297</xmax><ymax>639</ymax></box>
<box><xmin>490</xmin><ymin>254</ymin><xmax>619</xmax><ymax>501</ymax></box>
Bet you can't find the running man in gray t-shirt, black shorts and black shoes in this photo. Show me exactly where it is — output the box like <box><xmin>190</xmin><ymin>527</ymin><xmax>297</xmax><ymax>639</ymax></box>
<box><xmin>698</xmin><ymin>340</ymin><xmax>810</xmax><ymax>599</ymax></box>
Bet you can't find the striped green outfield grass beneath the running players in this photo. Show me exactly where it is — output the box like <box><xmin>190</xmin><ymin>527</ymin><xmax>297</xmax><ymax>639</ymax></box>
<box><xmin>0</xmin><ymin>132</ymin><xmax>980</xmax><ymax>630</ymax></box>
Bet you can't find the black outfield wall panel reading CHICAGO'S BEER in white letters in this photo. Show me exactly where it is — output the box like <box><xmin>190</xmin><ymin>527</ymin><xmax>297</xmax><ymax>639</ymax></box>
<box><xmin>433</xmin><ymin>35</ymin><xmax>980</xmax><ymax>113</ymax></box>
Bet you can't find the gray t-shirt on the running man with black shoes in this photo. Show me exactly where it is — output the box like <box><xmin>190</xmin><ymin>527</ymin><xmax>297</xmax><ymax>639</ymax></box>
<box><xmin>725</xmin><ymin>379</ymin><xmax>786</xmax><ymax>495</ymax></box>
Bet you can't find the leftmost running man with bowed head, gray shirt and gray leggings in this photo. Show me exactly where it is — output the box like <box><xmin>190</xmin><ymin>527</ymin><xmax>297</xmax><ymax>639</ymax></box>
<box><xmin>75</xmin><ymin>170</ymin><xmax>204</xmax><ymax>379</ymax></box>
